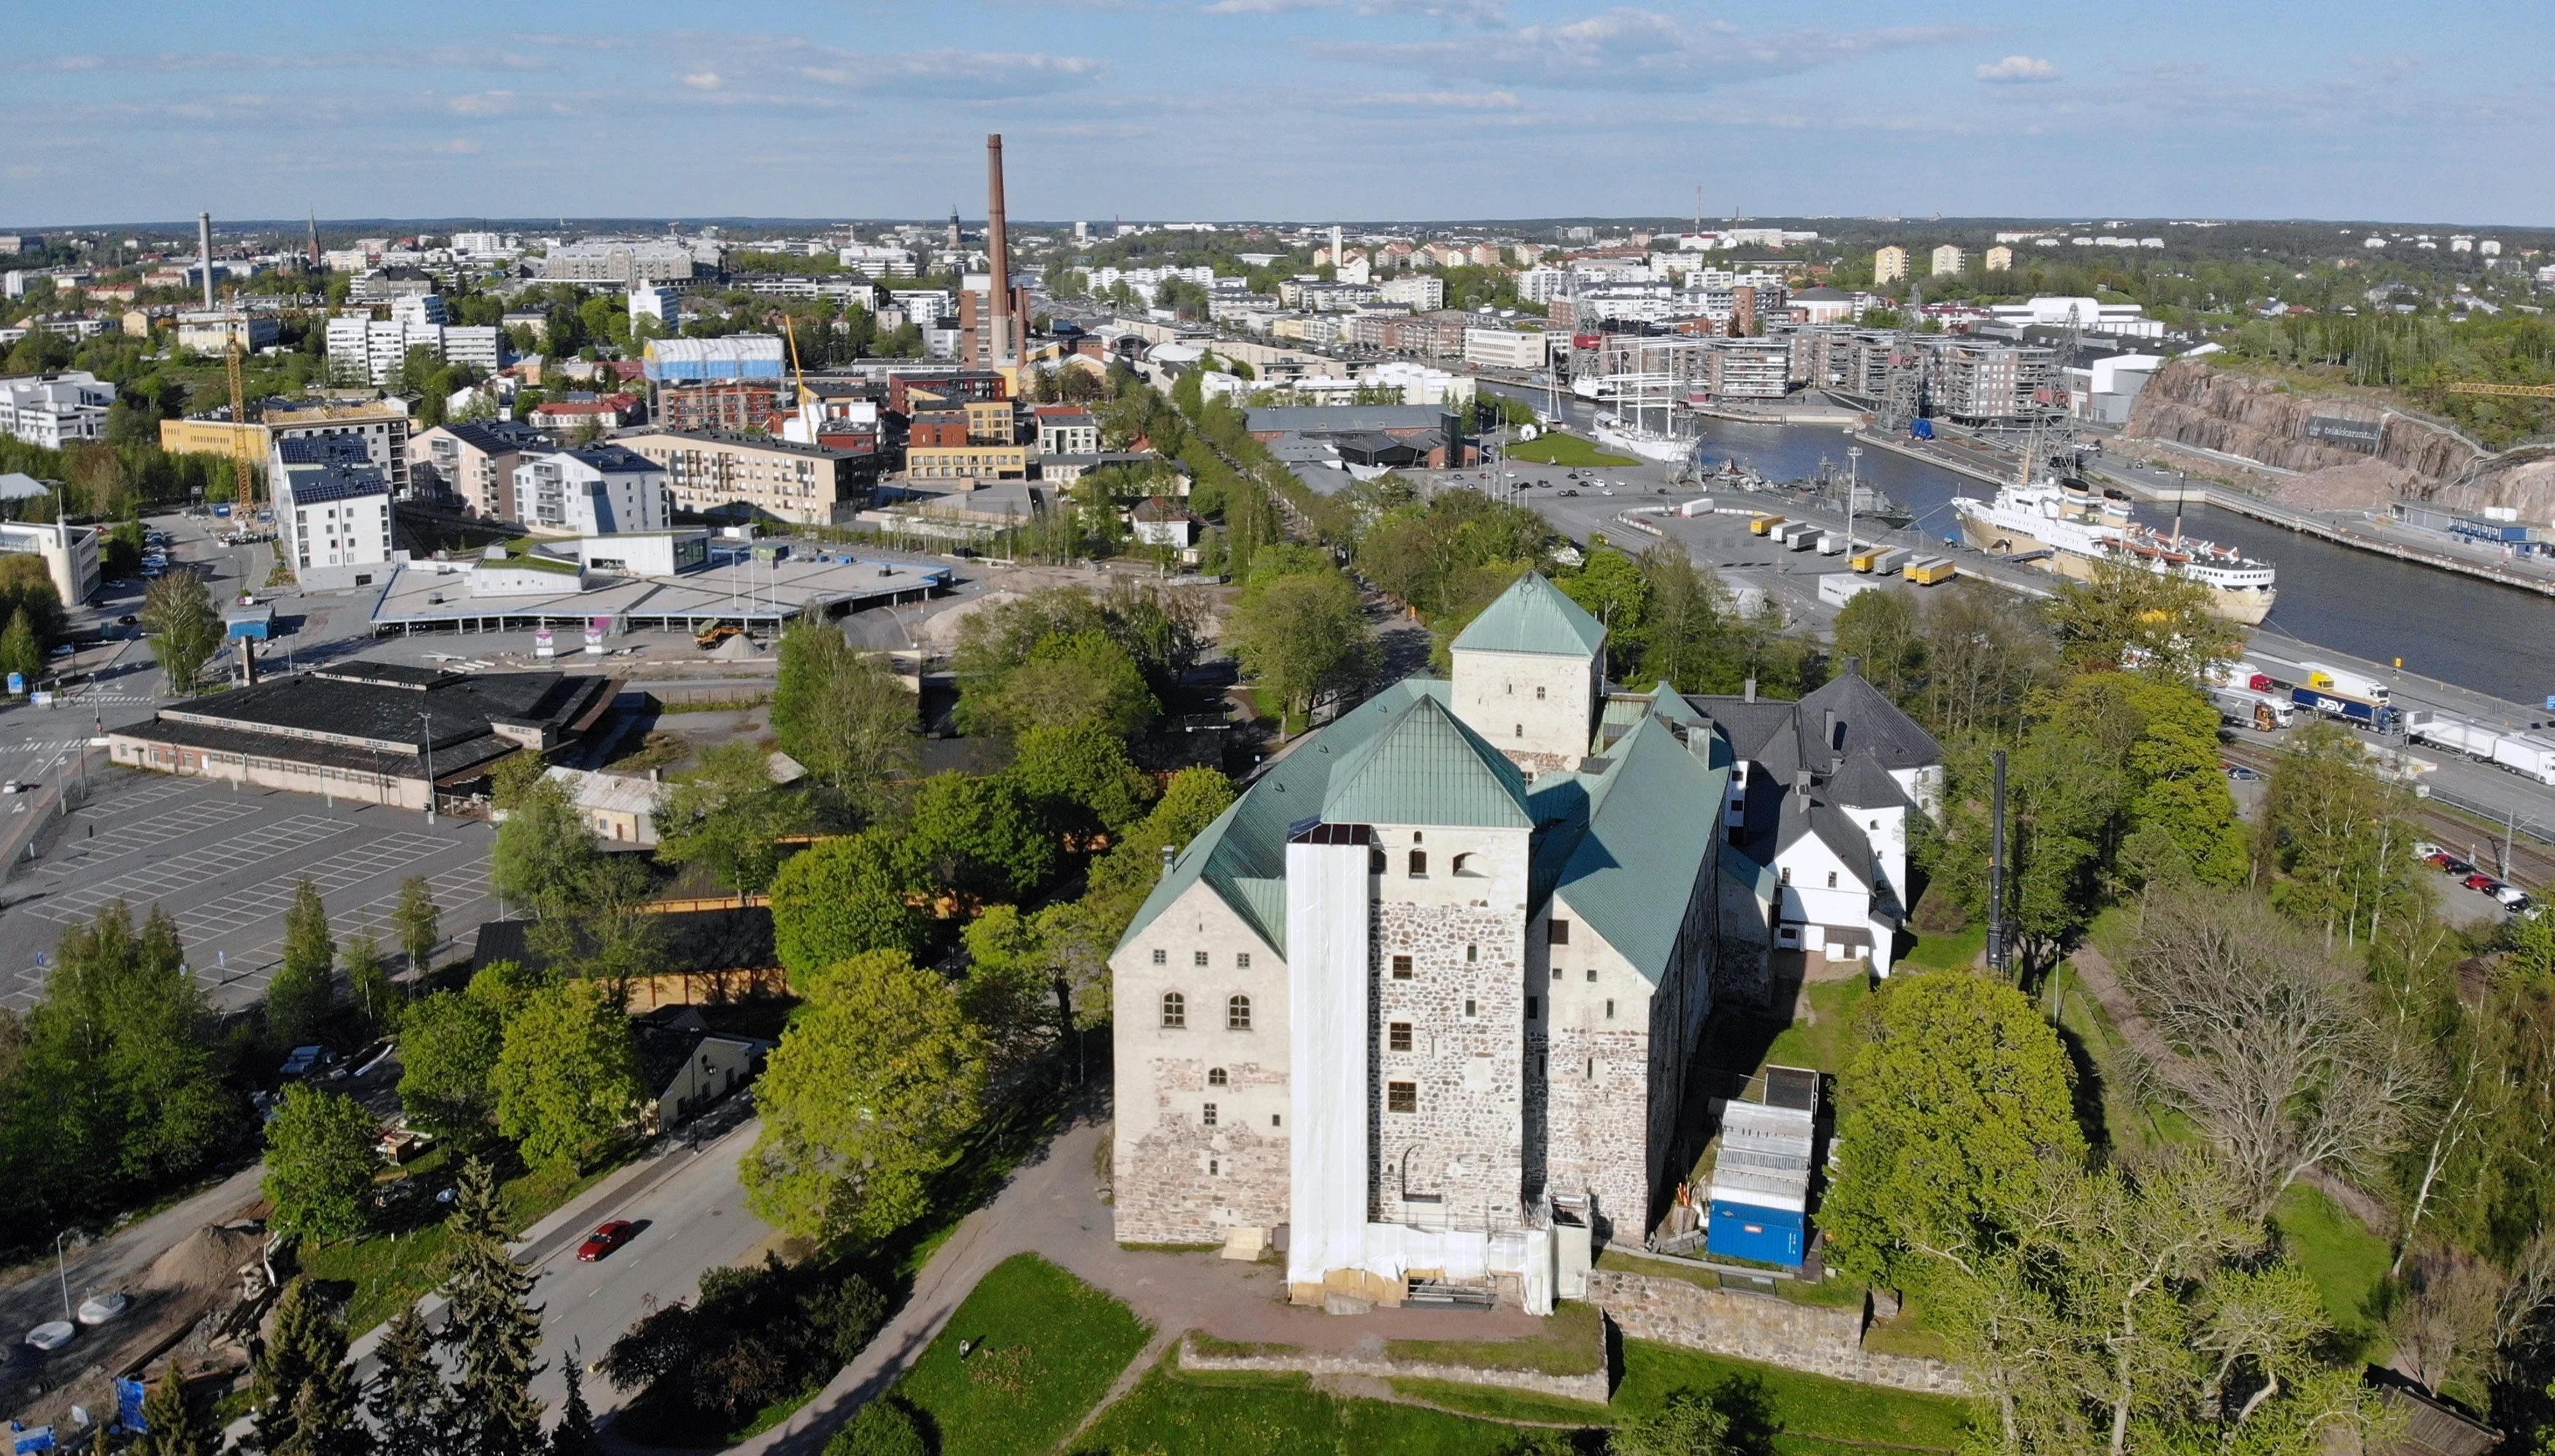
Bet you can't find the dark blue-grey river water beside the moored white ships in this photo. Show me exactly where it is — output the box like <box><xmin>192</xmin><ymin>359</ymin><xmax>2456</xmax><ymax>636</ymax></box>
<box><xmin>1495</xmin><ymin>386</ymin><xmax>2555</xmax><ymax>703</ymax></box>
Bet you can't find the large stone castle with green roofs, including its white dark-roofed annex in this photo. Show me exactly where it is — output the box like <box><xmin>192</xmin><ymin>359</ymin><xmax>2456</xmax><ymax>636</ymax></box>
<box><xmin>1109</xmin><ymin>575</ymin><xmax>1940</xmax><ymax>1313</ymax></box>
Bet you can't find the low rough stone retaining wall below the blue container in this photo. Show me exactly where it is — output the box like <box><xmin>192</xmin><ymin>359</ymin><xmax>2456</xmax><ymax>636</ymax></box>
<box><xmin>1589</xmin><ymin>1270</ymin><xmax>1970</xmax><ymax>1395</ymax></box>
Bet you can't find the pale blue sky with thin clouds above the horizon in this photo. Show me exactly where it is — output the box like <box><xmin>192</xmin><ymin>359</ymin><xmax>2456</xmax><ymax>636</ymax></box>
<box><xmin>0</xmin><ymin>0</ymin><xmax>2555</xmax><ymax>225</ymax></box>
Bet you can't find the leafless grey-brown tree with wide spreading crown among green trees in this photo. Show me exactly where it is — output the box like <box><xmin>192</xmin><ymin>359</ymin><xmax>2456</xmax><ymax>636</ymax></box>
<box><xmin>2121</xmin><ymin>889</ymin><xmax>2430</xmax><ymax>1216</ymax></box>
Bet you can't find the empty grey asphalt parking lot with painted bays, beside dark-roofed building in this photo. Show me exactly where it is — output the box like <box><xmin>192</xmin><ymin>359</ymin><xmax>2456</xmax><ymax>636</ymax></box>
<box><xmin>0</xmin><ymin>769</ymin><xmax>499</xmax><ymax>1012</ymax></box>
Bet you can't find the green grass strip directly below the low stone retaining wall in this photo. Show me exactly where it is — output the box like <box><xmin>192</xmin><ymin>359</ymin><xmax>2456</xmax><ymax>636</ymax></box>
<box><xmin>1615</xmin><ymin>1338</ymin><xmax>1970</xmax><ymax>1451</ymax></box>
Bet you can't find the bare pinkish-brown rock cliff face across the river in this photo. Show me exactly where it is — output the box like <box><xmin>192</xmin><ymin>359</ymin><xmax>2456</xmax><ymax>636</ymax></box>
<box><xmin>2124</xmin><ymin>361</ymin><xmax>2481</xmax><ymax>475</ymax></box>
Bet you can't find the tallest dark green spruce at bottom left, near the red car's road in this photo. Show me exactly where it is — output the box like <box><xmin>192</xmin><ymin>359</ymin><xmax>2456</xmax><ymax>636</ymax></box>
<box><xmin>442</xmin><ymin>1158</ymin><xmax>542</xmax><ymax>1456</ymax></box>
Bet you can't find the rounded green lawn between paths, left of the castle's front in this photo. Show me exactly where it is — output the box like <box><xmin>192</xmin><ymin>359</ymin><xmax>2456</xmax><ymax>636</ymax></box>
<box><xmin>889</xmin><ymin>1255</ymin><xmax>1150</xmax><ymax>1456</ymax></box>
